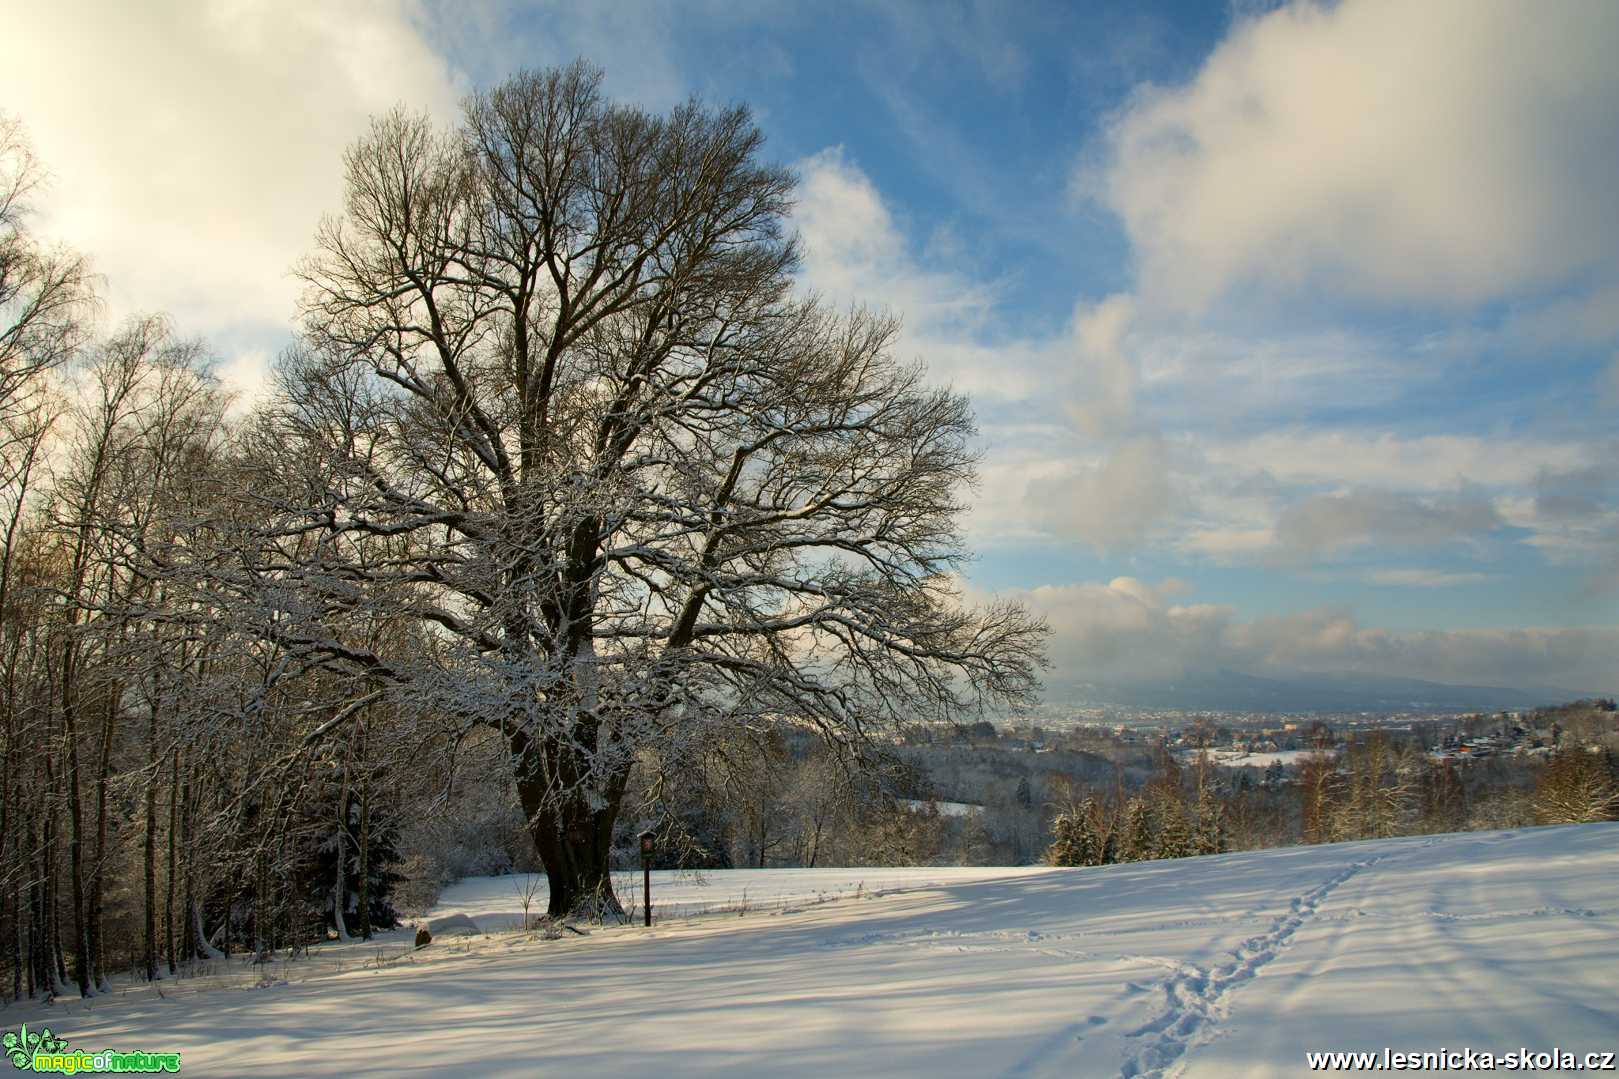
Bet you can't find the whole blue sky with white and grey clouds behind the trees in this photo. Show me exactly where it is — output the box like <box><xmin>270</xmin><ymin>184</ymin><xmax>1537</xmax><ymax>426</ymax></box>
<box><xmin>0</xmin><ymin>0</ymin><xmax>1619</xmax><ymax>692</ymax></box>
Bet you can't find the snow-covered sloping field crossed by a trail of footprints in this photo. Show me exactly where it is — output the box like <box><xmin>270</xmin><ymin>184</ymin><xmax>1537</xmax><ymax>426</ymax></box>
<box><xmin>12</xmin><ymin>825</ymin><xmax>1619</xmax><ymax>1079</ymax></box>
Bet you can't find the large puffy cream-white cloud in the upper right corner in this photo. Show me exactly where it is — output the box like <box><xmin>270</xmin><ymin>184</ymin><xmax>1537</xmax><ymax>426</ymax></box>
<box><xmin>1081</xmin><ymin>0</ymin><xmax>1619</xmax><ymax>309</ymax></box>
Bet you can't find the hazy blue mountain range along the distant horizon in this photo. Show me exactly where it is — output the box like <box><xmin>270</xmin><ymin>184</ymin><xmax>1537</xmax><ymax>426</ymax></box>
<box><xmin>1046</xmin><ymin>669</ymin><xmax>1590</xmax><ymax>713</ymax></box>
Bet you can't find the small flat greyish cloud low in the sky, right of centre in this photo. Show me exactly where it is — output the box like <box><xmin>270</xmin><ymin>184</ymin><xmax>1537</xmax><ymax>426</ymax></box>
<box><xmin>1276</xmin><ymin>489</ymin><xmax>1506</xmax><ymax>559</ymax></box>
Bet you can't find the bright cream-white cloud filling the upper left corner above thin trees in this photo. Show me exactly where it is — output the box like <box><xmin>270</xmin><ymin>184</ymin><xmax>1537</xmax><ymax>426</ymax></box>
<box><xmin>0</xmin><ymin>0</ymin><xmax>460</xmax><ymax>346</ymax></box>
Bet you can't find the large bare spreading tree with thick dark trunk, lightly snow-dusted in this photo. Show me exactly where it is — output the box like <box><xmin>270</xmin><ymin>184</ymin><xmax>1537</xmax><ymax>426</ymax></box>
<box><xmin>210</xmin><ymin>65</ymin><xmax>1044</xmax><ymax>914</ymax></box>
